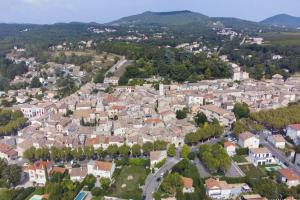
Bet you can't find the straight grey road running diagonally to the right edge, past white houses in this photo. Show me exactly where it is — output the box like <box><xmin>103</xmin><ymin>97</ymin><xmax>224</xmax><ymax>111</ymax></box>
<box><xmin>259</xmin><ymin>133</ymin><xmax>300</xmax><ymax>176</ymax></box>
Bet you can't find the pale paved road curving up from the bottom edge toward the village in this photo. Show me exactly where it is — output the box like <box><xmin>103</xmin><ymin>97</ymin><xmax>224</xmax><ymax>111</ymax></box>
<box><xmin>143</xmin><ymin>156</ymin><xmax>181</xmax><ymax>200</ymax></box>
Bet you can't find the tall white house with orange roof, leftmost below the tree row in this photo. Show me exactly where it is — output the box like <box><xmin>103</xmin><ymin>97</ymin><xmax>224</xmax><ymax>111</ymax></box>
<box><xmin>28</xmin><ymin>160</ymin><xmax>53</xmax><ymax>185</ymax></box>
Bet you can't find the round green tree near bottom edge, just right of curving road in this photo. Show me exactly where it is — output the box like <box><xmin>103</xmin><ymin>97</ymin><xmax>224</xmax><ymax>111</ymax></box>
<box><xmin>161</xmin><ymin>173</ymin><xmax>183</xmax><ymax>195</ymax></box>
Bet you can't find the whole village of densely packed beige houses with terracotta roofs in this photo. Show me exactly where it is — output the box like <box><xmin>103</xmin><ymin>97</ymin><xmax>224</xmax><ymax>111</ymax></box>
<box><xmin>0</xmin><ymin>47</ymin><xmax>300</xmax><ymax>199</ymax></box>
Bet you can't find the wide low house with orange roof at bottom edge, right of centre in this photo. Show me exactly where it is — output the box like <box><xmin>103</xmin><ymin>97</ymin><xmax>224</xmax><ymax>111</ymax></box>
<box><xmin>205</xmin><ymin>178</ymin><xmax>250</xmax><ymax>199</ymax></box>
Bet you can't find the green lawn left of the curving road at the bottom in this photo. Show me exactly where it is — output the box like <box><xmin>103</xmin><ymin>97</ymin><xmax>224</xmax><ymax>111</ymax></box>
<box><xmin>112</xmin><ymin>165</ymin><xmax>147</xmax><ymax>199</ymax></box>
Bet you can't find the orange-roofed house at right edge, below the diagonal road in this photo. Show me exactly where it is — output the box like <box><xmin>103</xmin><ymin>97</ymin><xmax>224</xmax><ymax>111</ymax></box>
<box><xmin>277</xmin><ymin>168</ymin><xmax>300</xmax><ymax>187</ymax></box>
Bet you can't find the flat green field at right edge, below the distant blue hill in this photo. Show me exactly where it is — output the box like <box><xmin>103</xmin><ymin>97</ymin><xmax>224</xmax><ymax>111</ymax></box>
<box><xmin>260</xmin><ymin>32</ymin><xmax>300</xmax><ymax>46</ymax></box>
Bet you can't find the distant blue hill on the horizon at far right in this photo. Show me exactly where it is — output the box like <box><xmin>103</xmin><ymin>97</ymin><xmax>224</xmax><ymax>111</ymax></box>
<box><xmin>260</xmin><ymin>14</ymin><xmax>300</xmax><ymax>28</ymax></box>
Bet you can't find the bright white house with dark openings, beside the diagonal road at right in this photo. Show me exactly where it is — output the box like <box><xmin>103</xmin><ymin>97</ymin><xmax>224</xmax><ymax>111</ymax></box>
<box><xmin>249</xmin><ymin>147</ymin><xmax>275</xmax><ymax>166</ymax></box>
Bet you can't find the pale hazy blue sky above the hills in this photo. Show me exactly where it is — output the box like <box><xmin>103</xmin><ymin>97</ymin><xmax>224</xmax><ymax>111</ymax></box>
<box><xmin>0</xmin><ymin>0</ymin><xmax>300</xmax><ymax>24</ymax></box>
